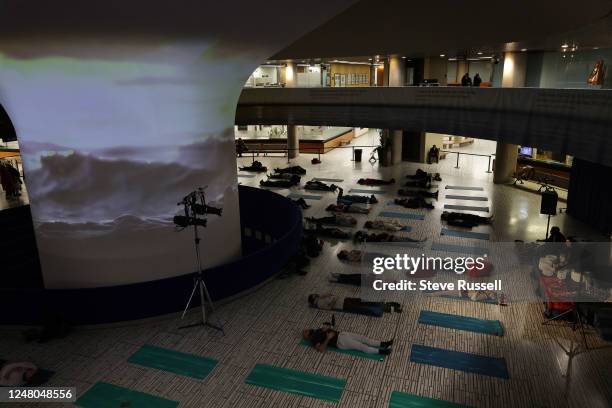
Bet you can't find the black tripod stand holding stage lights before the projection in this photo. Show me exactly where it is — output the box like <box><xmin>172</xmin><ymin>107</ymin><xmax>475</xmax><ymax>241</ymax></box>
<box><xmin>174</xmin><ymin>188</ymin><xmax>225</xmax><ymax>334</ymax></box>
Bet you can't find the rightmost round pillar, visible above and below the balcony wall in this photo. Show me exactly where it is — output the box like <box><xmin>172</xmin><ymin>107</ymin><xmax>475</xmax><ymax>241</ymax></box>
<box><xmin>493</xmin><ymin>52</ymin><xmax>527</xmax><ymax>184</ymax></box>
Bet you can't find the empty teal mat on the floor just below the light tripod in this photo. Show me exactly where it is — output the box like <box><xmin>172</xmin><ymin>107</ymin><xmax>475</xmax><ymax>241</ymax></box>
<box><xmin>128</xmin><ymin>345</ymin><xmax>217</xmax><ymax>380</ymax></box>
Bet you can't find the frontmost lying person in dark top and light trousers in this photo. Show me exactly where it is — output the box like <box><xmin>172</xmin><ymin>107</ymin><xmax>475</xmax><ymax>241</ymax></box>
<box><xmin>302</xmin><ymin>324</ymin><xmax>393</xmax><ymax>355</ymax></box>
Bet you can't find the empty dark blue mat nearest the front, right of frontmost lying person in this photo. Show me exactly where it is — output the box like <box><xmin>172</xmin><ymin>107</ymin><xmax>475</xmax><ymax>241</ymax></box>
<box><xmin>410</xmin><ymin>344</ymin><xmax>510</xmax><ymax>380</ymax></box>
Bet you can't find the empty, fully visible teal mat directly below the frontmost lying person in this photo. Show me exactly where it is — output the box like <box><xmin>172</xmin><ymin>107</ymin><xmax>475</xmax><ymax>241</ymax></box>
<box><xmin>245</xmin><ymin>364</ymin><xmax>346</xmax><ymax>402</ymax></box>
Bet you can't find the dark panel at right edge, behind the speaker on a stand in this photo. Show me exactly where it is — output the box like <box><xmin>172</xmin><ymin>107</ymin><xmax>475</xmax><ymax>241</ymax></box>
<box><xmin>567</xmin><ymin>158</ymin><xmax>612</xmax><ymax>234</ymax></box>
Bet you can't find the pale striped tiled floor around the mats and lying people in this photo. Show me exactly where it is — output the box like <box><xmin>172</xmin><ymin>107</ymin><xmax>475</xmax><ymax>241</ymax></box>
<box><xmin>0</xmin><ymin>136</ymin><xmax>612</xmax><ymax>408</ymax></box>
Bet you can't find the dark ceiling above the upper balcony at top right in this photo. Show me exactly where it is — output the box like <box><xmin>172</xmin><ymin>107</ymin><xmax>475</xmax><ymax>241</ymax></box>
<box><xmin>271</xmin><ymin>0</ymin><xmax>612</xmax><ymax>60</ymax></box>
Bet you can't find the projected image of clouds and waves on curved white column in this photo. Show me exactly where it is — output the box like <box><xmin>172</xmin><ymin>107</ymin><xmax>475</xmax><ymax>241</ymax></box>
<box><xmin>0</xmin><ymin>41</ymin><xmax>253</xmax><ymax>288</ymax></box>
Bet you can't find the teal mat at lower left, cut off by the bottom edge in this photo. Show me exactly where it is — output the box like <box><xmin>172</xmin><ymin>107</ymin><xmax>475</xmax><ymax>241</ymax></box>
<box><xmin>75</xmin><ymin>382</ymin><xmax>178</xmax><ymax>408</ymax></box>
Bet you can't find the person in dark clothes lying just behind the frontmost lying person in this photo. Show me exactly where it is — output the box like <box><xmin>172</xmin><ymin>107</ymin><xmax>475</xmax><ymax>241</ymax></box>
<box><xmin>308</xmin><ymin>293</ymin><xmax>402</xmax><ymax>317</ymax></box>
